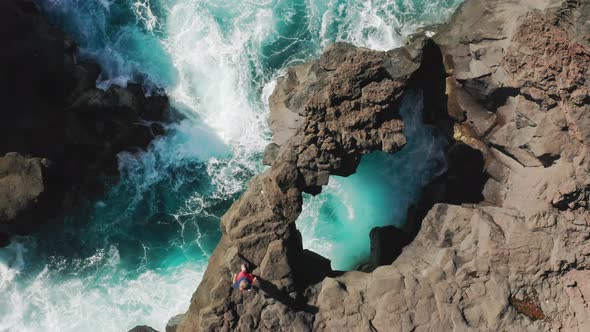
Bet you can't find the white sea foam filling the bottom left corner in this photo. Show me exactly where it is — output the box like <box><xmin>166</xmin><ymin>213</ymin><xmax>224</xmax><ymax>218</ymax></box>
<box><xmin>0</xmin><ymin>243</ymin><xmax>203</xmax><ymax>332</ymax></box>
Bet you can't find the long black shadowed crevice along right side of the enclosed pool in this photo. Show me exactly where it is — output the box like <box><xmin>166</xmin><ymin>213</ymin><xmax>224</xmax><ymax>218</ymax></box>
<box><xmin>359</xmin><ymin>39</ymin><xmax>464</xmax><ymax>272</ymax></box>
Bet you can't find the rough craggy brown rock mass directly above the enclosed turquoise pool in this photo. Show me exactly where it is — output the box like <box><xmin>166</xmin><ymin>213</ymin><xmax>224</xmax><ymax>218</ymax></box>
<box><xmin>266</xmin><ymin>43</ymin><xmax>428</xmax><ymax>193</ymax></box>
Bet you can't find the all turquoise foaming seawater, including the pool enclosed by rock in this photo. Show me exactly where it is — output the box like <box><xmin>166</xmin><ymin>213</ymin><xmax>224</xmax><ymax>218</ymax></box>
<box><xmin>0</xmin><ymin>0</ymin><xmax>460</xmax><ymax>331</ymax></box>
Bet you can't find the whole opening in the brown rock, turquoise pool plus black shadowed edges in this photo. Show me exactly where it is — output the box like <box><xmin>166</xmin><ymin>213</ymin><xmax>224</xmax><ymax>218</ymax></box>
<box><xmin>297</xmin><ymin>41</ymin><xmax>488</xmax><ymax>272</ymax></box>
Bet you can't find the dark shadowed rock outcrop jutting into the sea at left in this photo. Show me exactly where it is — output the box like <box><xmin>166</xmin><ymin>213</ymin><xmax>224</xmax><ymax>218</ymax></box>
<box><xmin>0</xmin><ymin>0</ymin><xmax>172</xmax><ymax>242</ymax></box>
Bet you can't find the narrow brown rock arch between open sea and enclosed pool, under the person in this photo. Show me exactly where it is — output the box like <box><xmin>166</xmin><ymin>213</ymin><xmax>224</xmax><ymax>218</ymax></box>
<box><xmin>178</xmin><ymin>35</ymin><xmax>440</xmax><ymax>331</ymax></box>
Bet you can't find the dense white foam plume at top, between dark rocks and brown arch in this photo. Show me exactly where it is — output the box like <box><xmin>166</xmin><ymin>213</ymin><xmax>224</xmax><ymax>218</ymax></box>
<box><xmin>166</xmin><ymin>1</ymin><xmax>271</xmax><ymax>152</ymax></box>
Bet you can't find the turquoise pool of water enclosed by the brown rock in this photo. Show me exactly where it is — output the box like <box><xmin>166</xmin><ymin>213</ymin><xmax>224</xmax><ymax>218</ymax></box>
<box><xmin>297</xmin><ymin>92</ymin><xmax>448</xmax><ymax>271</ymax></box>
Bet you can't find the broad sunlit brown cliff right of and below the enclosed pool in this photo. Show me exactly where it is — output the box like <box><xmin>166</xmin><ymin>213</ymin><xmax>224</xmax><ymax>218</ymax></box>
<box><xmin>314</xmin><ymin>1</ymin><xmax>590</xmax><ymax>331</ymax></box>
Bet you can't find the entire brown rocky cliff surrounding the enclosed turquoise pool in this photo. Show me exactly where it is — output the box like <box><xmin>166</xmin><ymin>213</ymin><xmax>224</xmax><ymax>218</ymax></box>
<box><xmin>171</xmin><ymin>0</ymin><xmax>590</xmax><ymax>331</ymax></box>
